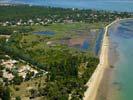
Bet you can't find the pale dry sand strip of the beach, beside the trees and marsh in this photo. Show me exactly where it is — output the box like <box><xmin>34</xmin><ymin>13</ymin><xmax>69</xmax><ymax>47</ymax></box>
<box><xmin>84</xmin><ymin>20</ymin><xmax>118</xmax><ymax>100</ymax></box>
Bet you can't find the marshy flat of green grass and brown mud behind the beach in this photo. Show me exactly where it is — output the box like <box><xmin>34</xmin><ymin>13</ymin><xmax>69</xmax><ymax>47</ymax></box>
<box><xmin>21</xmin><ymin>23</ymin><xmax>107</xmax><ymax>50</ymax></box>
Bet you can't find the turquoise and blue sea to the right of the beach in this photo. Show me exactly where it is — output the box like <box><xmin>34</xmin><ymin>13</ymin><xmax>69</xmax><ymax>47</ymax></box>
<box><xmin>110</xmin><ymin>20</ymin><xmax>133</xmax><ymax>100</ymax></box>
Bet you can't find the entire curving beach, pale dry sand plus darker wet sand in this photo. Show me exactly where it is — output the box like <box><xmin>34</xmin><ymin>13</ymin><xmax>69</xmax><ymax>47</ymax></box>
<box><xmin>83</xmin><ymin>18</ymin><xmax>133</xmax><ymax>100</ymax></box>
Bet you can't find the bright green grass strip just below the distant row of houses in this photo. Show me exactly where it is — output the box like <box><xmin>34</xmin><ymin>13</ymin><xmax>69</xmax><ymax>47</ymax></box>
<box><xmin>32</xmin><ymin>22</ymin><xmax>107</xmax><ymax>37</ymax></box>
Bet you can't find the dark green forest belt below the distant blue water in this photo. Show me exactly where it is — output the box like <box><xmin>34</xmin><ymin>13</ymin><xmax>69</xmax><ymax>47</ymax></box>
<box><xmin>0</xmin><ymin>5</ymin><xmax>131</xmax><ymax>22</ymax></box>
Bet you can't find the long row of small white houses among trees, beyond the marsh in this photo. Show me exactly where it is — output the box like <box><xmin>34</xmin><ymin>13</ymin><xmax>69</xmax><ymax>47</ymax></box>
<box><xmin>0</xmin><ymin>11</ymin><xmax>131</xmax><ymax>26</ymax></box>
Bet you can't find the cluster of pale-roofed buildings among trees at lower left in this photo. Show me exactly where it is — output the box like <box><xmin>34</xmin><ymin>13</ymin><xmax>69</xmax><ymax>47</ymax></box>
<box><xmin>0</xmin><ymin>55</ymin><xmax>39</xmax><ymax>81</ymax></box>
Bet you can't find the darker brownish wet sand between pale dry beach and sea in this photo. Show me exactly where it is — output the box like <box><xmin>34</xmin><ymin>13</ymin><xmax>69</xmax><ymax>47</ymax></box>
<box><xmin>96</xmin><ymin>39</ymin><xmax>119</xmax><ymax>100</ymax></box>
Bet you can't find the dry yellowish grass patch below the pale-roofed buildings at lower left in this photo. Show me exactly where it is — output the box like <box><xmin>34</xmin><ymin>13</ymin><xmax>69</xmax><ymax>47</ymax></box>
<box><xmin>10</xmin><ymin>77</ymin><xmax>46</xmax><ymax>100</ymax></box>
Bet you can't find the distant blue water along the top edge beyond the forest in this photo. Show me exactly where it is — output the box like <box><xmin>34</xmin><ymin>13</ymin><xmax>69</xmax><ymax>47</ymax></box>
<box><xmin>4</xmin><ymin>0</ymin><xmax>133</xmax><ymax>12</ymax></box>
